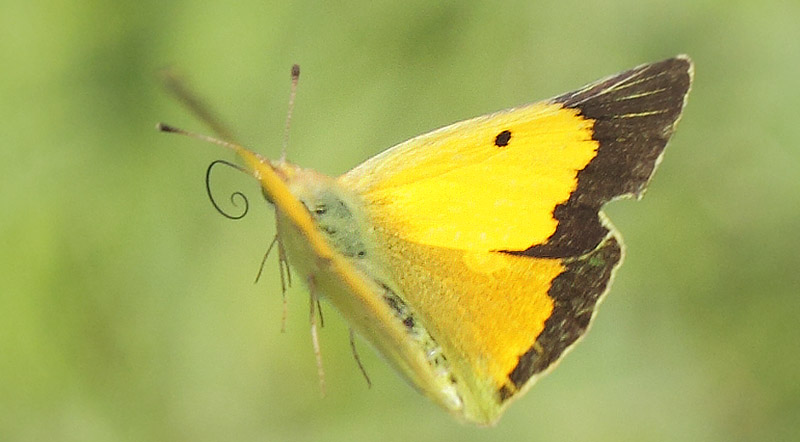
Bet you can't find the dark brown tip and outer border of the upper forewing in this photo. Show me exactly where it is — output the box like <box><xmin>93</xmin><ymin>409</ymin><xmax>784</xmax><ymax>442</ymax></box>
<box><xmin>510</xmin><ymin>57</ymin><xmax>692</xmax><ymax>258</ymax></box>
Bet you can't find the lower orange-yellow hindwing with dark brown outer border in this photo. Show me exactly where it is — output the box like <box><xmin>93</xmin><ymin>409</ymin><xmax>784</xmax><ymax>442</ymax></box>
<box><xmin>372</xmin><ymin>223</ymin><xmax>622</xmax><ymax>425</ymax></box>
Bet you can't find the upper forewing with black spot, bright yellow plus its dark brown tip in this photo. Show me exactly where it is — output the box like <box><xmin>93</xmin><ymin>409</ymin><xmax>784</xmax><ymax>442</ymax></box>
<box><xmin>340</xmin><ymin>57</ymin><xmax>690</xmax><ymax>258</ymax></box>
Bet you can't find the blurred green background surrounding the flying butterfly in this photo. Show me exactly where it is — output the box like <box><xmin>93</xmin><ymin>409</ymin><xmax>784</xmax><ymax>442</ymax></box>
<box><xmin>0</xmin><ymin>0</ymin><xmax>800</xmax><ymax>442</ymax></box>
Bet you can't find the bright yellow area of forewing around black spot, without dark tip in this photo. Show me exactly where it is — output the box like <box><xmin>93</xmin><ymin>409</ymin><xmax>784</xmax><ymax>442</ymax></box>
<box><xmin>343</xmin><ymin>103</ymin><xmax>598</xmax><ymax>250</ymax></box>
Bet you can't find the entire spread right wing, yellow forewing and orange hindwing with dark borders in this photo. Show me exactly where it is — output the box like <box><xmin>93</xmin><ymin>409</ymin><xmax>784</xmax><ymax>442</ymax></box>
<box><xmin>332</xmin><ymin>57</ymin><xmax>692</xmax><ymax>423</ymax></box>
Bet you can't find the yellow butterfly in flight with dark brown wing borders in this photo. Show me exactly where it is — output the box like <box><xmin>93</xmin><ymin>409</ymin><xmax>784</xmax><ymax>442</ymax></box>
<box><xmin>160</xmin><ymin>56</ymin><xmax>693</xmax><ymax>425</ymax></box>
